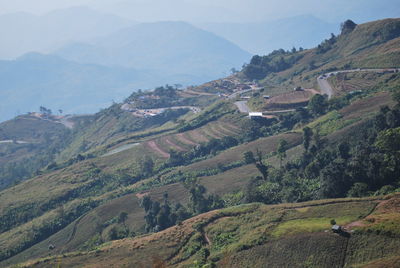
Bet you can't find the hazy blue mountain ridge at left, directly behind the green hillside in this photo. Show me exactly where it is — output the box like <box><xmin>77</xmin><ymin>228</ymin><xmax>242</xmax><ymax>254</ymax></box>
<box><xmin>0</xmin><ymin>53</ymin><xmax>192</xmax><ymax>121</ymax></box>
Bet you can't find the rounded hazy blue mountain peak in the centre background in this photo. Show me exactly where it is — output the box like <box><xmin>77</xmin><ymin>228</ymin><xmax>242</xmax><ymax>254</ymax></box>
<box><xmin>55</xmin><ymin>21</ymin><xmax>251</xmax><ymax>78</ymax></box>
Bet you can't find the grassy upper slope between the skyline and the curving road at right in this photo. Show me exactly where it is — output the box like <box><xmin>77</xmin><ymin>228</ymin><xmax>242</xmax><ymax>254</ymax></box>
<box><xmin>252</xmin><ymin>19</ymin><xmax>400</xmax><ymax>111</ymax></box>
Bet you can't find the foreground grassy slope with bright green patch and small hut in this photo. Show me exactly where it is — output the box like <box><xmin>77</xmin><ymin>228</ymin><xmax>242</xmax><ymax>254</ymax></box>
<box><xmin>18</xmin><ymin>195</ymin><xmax>400</xmax><ymax>267</ymax></box>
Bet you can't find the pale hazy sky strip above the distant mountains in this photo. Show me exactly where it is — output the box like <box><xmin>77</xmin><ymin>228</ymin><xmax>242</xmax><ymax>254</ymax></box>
<box><xmin>0</xmin><ymin>0</ymin><xmax>400</xmax><ymax>22</ymax></box>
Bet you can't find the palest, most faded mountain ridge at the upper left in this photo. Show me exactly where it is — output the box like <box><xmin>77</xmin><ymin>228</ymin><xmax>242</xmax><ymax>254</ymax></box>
<box><xmin>0</xmin><ymin>7</ymin><xmax>134</xmax><ymax>59</ymax></box>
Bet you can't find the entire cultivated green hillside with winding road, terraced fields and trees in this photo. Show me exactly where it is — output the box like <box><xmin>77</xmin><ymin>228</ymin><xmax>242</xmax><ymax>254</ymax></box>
<box><xmin>0</xmin><ymin>19</ymin><xmax>400</xmax><ymax>267</ymax></box>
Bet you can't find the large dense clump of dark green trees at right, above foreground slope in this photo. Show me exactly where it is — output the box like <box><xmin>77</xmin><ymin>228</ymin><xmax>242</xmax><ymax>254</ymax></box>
<box><xmin>244</xmin><ymin>93</ymin><xmax>400</xmax><ymax>203</ymax></box>
